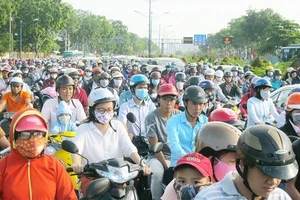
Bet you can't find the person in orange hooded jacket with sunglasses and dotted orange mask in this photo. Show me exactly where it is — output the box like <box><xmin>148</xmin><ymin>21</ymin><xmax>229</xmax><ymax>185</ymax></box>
<box><xmin>0</xmin><ymin>108</ymin><xmax>77</xmax><ymax>200</ymax></box>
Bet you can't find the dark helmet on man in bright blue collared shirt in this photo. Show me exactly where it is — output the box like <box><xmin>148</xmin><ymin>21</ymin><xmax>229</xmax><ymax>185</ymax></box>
<box><xmin>182</xmin><ymin>85</ymin><xmax>207</xmax><ymax>103</ymax></box>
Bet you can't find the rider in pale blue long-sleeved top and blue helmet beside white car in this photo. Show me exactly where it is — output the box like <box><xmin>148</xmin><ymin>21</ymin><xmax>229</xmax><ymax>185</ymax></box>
<box><xmin>247</xmin><ymin>78</ymin><xmax>279</xmax><ymax>127</ymax></box>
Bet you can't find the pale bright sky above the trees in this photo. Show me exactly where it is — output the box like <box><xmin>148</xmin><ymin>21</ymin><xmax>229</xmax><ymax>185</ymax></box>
<box><xmin>63</xmin><ymin>0</ymin><xmax>300</xmax><ymax>39</ymax></box>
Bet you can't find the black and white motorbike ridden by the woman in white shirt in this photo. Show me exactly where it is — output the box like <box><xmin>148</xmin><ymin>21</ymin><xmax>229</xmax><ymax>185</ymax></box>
<box><xmin>62</xmin><ymin>140</ymin><xmax>163</xmax><ymax>200</ymax></box>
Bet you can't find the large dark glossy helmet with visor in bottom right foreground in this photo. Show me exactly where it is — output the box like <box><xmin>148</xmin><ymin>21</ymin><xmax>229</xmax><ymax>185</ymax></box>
<box><xmin>237</xmin><ymin>124</ymin><xmax>298</xmax><ymax>181</ymax></box>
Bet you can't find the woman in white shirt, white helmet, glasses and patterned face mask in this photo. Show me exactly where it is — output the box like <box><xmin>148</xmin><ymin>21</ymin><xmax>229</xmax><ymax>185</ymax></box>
<box><xmin>71</xmin><ymin>88</ymin><xmax>151</xmax><ymax>194</ymax></box>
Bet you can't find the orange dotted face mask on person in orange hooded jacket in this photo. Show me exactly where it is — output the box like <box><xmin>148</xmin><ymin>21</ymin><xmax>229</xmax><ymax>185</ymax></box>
<box><xmin>16</xmin><ymin>137</ymin><xmax>47</xmax><ymax>158</ymax></box>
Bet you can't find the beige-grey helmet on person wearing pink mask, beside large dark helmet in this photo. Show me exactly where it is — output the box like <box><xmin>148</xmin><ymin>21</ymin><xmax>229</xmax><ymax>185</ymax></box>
<box><xmin>195</xmin><ymin>122</ymin><xmax>241</xmax><ymax>153</ymax></box>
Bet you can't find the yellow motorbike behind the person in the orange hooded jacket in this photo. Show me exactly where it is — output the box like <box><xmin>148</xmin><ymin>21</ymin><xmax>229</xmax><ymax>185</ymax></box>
<box><xmin>46</xmin><ymin>131</ymin><xmax>79</xmax><ymax>191</ymax></box>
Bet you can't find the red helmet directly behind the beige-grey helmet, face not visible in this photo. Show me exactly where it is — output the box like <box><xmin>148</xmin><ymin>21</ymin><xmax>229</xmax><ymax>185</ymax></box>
<box><xmin>208</xmin><ymin>108</ymin><xmax>240</xmax><ymax>125</ymax></box>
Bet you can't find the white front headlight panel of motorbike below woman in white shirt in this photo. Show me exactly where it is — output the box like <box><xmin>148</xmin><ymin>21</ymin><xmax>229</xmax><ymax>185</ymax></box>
<box><xmin>96</xmin><ymin>166</ymin><xmax>139</xmax><ymax>183</ymax></box>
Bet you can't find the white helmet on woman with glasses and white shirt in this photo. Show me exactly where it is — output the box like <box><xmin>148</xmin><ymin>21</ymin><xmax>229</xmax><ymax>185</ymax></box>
<box><xmin>88</xmin><ymin>88</ymin><xmax>116</xmax><ymax>107</ymax></box>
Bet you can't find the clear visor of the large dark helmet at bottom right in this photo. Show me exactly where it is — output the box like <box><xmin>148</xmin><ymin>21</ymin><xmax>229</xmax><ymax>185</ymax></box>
<box><xmin>256</xmin><ymin>160</ymin><xmax>298</xmax><ymax>180</ymax></box>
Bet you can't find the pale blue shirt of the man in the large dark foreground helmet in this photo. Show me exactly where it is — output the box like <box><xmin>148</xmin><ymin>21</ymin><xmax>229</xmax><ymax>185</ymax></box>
<box><xmin>195</xmin><ymin>172</ymin><xmax>291</xmax><ymax>200</ymax></box>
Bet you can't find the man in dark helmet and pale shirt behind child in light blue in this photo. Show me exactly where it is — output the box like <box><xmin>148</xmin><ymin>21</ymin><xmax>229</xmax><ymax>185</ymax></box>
<box><xmin>42</xmin><ymin>75</ymin><xmax>86</xmax><ymax>130</ymax></box>
